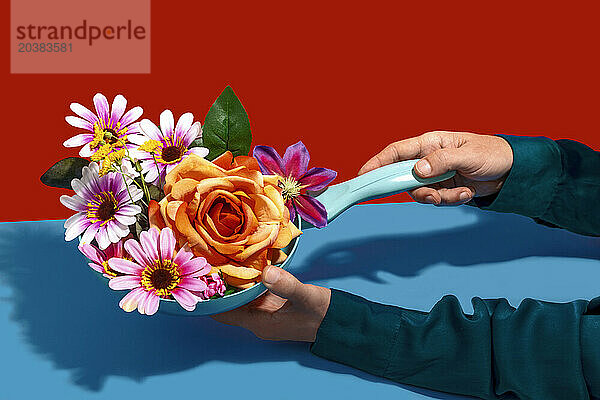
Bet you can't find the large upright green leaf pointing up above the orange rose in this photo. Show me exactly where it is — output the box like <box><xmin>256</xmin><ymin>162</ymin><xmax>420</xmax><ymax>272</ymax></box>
<box><xmin>202</xmin><ymin>86</ymin><xmax>252</xmax><ymax>160</ymax></box>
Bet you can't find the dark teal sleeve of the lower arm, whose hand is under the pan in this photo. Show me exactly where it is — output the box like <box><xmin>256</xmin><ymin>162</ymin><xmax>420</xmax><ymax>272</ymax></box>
<box><xmin>311</xmin><ymin>290</ymin><xmax>600</xmax><ymax>400</ymax></box>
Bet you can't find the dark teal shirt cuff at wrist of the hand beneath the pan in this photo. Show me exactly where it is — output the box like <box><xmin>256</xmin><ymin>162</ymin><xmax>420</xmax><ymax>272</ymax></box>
<box><xmin>310</xmin><ymin>289</ymin><xmax>400</xmax><ymax>376</ymax></box>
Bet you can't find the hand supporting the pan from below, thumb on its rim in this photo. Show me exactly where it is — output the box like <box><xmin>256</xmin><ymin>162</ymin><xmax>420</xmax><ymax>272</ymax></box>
<box><xmin>212</xmin><ymin>266</ymin><xmax>331</xmax><ymax>342</ymax></box>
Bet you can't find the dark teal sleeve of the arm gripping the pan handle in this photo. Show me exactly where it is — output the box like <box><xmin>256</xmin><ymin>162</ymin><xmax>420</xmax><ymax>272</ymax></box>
<box><xmin>474</xmin><ymin>135</ymin><xmax>600</xmax><ymax>236</ymax></box>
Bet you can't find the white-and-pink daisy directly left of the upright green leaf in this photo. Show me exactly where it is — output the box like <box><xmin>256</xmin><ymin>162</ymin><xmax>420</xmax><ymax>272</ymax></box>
<box><xmin>129</xmin><ymin>110</ymin><xmax>208</xmax><ymax>186</ymax></box>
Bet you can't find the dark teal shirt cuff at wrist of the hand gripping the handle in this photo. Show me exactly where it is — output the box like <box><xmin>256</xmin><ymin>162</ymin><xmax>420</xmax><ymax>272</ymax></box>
<box><xmin>473</xmin><ymin>135</ymin><xmax>562</xmax><ymax>218</ymax></box>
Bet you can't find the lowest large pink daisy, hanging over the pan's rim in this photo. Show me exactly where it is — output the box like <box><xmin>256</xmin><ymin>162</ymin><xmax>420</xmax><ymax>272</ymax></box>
<box><xmin>108</xmin><ymin>228</ymin><xmax>212</xmax><ymax>315</ymax></box>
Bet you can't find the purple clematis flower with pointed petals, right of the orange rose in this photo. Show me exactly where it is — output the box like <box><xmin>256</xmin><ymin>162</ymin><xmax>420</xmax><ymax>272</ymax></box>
<box><xmin>253</xmin><ymin>142</ymin><xmax>337</xmax><ymax>228</ymax></box>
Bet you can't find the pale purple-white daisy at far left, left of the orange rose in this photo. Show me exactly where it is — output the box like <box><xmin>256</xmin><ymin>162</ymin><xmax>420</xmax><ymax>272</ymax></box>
<box><xmin>60</xmin><ymin>162</ymin><xmax>144</xmax><ymax>250</ymax></box>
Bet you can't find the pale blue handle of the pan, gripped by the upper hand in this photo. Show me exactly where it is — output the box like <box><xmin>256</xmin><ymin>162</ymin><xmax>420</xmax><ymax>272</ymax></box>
<box><xmin>310</xmin><ymin>160</ymin><xmax>456</xmax><ymax>229</ymax></box>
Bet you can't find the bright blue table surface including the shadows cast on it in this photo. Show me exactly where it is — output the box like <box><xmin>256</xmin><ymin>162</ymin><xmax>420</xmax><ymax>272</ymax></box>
<box><xmin>0</xmin><ymin>203</ymin><xmax>600</xmax><ymax>400</ymax></box>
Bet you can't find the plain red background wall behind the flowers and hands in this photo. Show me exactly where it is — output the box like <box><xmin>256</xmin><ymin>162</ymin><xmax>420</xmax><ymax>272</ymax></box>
<box><xmin>0</xmin><ymin>0</ymin><xmax>600</xmax><ymax>221</ymax></box>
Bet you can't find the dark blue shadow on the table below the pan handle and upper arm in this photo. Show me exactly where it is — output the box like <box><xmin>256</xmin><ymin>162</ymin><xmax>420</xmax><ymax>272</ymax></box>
<box><xmin>295</xmin><ymin>207</ymin><xmax>600</xmax><ymax>283</ymax></box>
